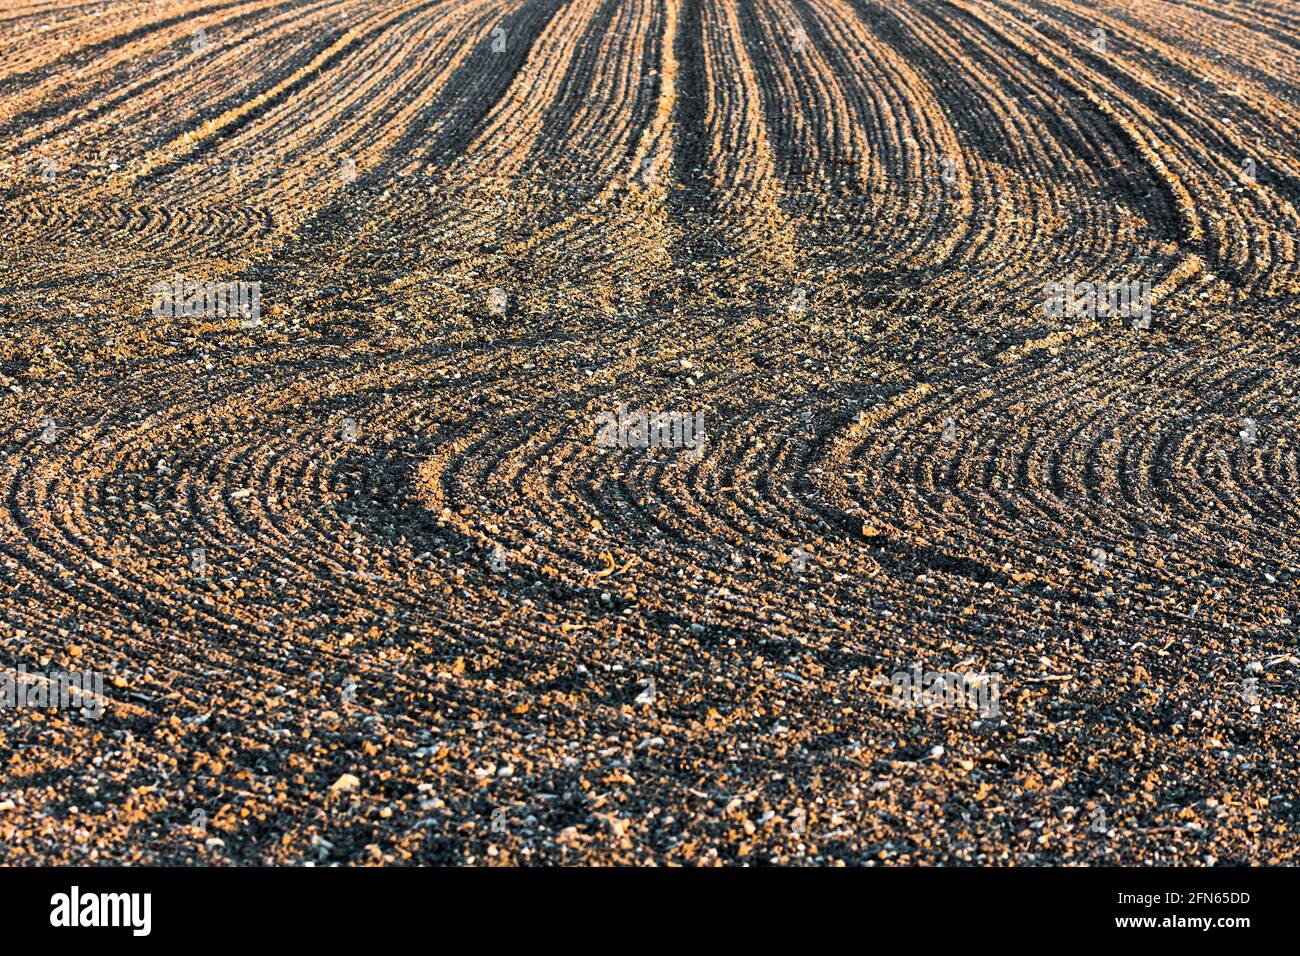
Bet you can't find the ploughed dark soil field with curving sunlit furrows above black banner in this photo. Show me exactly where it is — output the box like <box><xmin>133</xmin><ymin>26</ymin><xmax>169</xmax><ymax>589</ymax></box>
<box><xmin>0</xmin><ymin>0</ymin><xmax>1300</xmax><ymax>866</ymax></box>
